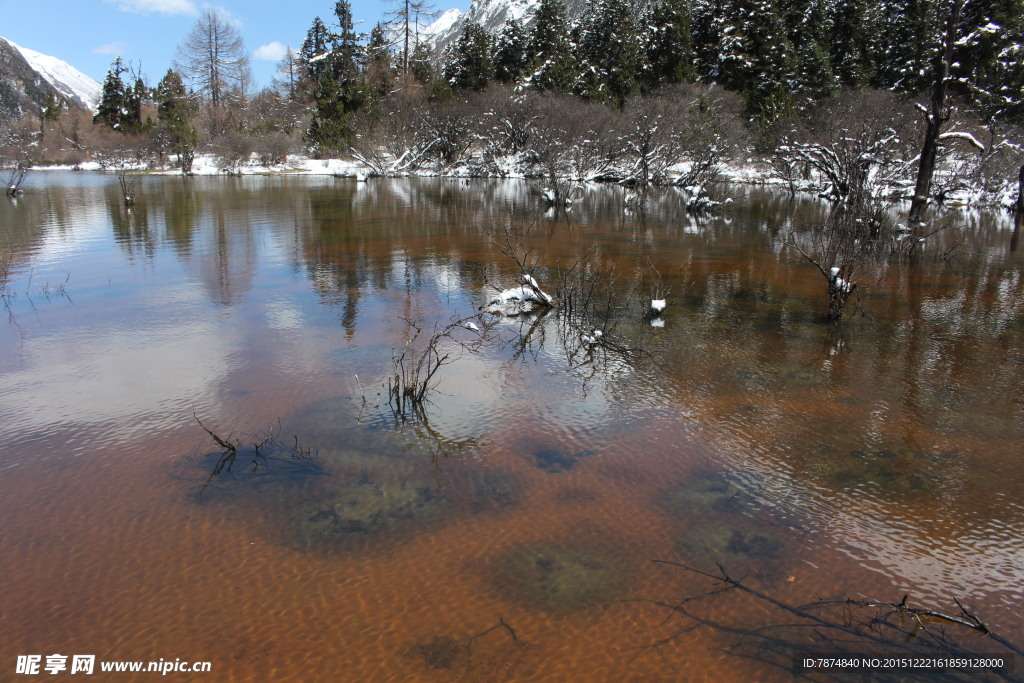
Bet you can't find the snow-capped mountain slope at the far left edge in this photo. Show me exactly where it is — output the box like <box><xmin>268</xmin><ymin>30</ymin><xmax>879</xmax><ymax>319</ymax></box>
<box><xmin>0</xmin><ymin>38</ymin><xmax>102</xmax><ymax>117</ymax></box>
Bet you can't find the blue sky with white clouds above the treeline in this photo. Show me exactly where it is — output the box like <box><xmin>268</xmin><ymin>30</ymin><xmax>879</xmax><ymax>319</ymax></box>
<box><xmin>0</xmin><ymin>0</ymin><xmax>469</xmax><ymax>86</ymax></box>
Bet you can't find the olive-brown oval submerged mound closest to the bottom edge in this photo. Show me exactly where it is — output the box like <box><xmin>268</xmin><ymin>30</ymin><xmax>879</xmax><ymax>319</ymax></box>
<box><xmin>496</xmin><ymin>546</ymin><xmax>626</xmax><ymax>610</ymax></box>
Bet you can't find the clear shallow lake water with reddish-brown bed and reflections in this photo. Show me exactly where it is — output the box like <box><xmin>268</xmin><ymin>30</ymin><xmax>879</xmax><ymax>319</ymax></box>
<box><xmin>0</xmin><ymin>173</ymin><xmax>1024</xmax><ymax>680</ymax></box>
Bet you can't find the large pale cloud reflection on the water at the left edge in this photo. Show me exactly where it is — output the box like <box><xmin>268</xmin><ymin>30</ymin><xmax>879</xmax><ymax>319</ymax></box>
<box><xmin>0</xmin><ymin>280</ymin><xmax>230</xmax><ymax>446</ymax></box>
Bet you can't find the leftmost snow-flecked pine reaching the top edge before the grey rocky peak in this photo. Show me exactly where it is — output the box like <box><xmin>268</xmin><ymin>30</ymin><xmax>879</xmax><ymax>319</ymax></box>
<box><xmin>525</xmin><ymin>0</ymin><xmax>577</xmax><ymax>92</ymax></box>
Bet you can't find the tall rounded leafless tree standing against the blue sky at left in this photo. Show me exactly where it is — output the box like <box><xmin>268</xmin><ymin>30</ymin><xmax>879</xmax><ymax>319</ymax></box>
<box><xmin>176</xmin><ymin>9</ymin><xmax>251</xmax><ymax>129</ymax></box>
